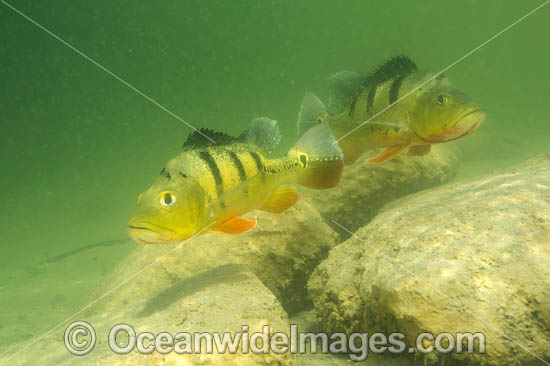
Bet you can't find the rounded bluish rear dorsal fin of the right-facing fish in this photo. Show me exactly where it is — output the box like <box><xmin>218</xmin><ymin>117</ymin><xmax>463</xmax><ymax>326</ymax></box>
<box><xmin>328</xmin><ymin>71</ymin><xmax>363</xmax><ymax>114</ymax></box>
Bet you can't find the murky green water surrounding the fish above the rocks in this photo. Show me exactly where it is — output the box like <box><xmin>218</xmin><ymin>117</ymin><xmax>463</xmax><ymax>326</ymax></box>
<box><xmin>0</xmin><ymin>0</ymin><xmax>550</xmax><ymax>360</ymax></box>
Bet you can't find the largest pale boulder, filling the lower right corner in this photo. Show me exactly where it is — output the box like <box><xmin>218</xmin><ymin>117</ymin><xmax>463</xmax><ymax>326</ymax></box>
<box><xmin>309</xmin><ymin>154</ymin><xmax>550</xmax><ymax>365</ymax></box>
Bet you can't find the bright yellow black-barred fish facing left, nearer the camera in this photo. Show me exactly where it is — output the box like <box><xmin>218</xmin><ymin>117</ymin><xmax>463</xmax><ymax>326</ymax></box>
<box><xmin>127</xmin><ymin>117</ymin><xmax>344</xmax><ymax>244</ymax></box>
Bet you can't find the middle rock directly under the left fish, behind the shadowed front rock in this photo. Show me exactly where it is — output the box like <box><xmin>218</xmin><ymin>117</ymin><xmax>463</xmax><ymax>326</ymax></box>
<box><xmin>91</xmin><ymin>200</ymin><xmax>338</xmax><ymax>312</ymax></box>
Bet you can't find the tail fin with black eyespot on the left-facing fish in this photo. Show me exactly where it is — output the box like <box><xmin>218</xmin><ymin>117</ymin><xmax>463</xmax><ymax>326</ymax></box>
<box><xmin>289</xmin><ymin>122</ymin><xmax>344</xmax><ymax>189</ymax></box>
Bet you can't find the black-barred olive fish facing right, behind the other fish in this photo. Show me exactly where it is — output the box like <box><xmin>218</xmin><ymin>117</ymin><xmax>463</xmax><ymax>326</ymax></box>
<box><xmin>298</xmin><ymin>56</ymin><xmax>486</xmax><ymax>164</ymax></box>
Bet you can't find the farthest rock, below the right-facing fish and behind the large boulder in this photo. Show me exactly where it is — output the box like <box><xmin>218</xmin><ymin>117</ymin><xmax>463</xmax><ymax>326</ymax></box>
<box><xmin>300</xmin><ymin>143</ymin><xmax>459</xmax><ymax>239</ymax></box>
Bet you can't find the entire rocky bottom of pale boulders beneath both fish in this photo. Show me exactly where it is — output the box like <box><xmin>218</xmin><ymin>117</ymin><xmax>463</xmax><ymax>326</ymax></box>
<box><xmin>0</xmin><ymin>150</ymin><xmax>550</xmax><ymax>366</ymax></box>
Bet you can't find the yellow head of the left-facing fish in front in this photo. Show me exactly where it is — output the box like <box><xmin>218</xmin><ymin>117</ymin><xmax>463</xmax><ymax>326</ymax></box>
<box><xmin>128</xmin><ymin>176</ymin><xmax>206</xmax><ymax>244</ymax></box>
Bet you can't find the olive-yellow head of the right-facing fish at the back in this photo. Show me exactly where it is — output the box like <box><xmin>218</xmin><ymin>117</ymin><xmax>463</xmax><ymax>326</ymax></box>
<box><xmin>409</xmin><ymin>74</ymin><xmax>486</xmax><ymax>143</ymax></box>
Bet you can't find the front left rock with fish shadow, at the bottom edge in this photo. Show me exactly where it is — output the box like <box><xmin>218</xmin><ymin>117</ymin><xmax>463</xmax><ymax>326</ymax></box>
<box><xmin>0</xmin><ymin>265</ymin><xmax>295</xmax><ymax>366</ymax></box>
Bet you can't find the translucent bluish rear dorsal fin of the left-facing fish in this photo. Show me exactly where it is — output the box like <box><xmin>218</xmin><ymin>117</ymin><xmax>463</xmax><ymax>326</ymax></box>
<box><xmin>238</xmin><ymin>117</ymin><xmax>281</xmax><ymax>153</ymax></box>
